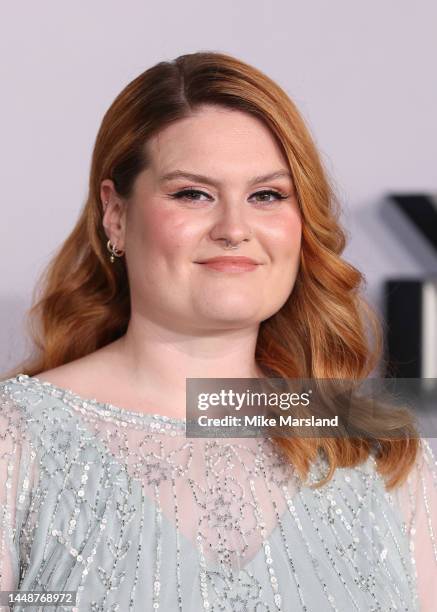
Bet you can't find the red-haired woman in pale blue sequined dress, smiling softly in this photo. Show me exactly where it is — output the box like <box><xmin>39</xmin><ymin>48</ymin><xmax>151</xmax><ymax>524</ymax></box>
<box><xmin>1</xmin><ymin>52</ymin><xmax>437</xmax><ymax>612</ymax></box>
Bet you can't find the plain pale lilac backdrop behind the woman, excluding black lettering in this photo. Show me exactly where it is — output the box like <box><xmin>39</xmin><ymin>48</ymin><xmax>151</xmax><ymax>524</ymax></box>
<box><xmin>0</xmin><ymin>0</ymin><xmax>437</xmax><ymax>454</ymax></box>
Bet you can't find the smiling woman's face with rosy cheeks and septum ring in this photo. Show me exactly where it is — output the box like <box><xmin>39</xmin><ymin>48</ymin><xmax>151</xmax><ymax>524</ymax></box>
<box><xmin>102</xmin><ymin>106</ymin><xmax>301</xmax><ymax>333</ymax></box>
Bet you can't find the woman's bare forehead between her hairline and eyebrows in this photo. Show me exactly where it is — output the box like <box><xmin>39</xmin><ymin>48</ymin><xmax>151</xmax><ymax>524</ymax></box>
<box><xmin>147</xmin><ymin>106</ymin><xmax>288</xmax><ymax>174</ymax></box>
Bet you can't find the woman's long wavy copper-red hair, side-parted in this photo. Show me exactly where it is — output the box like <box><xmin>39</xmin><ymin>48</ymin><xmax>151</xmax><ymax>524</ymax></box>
<box><xmin>6</xmin><ymin>52</ymin><xmax>419</xmax><ymax>489</ymax></box>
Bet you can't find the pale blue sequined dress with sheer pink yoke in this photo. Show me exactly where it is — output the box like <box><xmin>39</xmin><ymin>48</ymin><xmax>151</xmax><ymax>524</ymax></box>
<box><xmin>0</xmin><ymin>375</ymin><xmax>437</xmax><ymax>612</ymax></box>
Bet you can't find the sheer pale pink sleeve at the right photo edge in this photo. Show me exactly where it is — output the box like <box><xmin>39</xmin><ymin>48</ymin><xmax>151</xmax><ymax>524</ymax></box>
<box><xmin>395</xmin><ymin>438</ymin><xmax>437</xmax><ymax>612</ymax></box>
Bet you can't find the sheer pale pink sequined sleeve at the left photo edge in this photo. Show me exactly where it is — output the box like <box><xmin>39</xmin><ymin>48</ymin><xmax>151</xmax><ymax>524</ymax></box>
<box><xmin>0</xmin><ymin>383</ymin><xmax>35</xmax><ymax>612</ymax></box>
